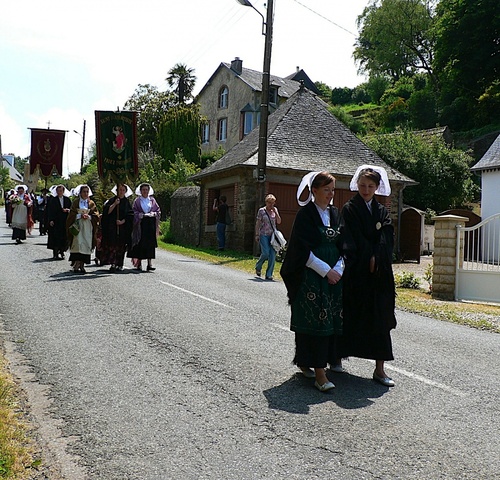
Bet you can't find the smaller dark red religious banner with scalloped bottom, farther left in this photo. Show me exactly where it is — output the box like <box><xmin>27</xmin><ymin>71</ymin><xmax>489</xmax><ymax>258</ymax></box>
<box><xmin>30</xmin><ymin>128</ymin><xmax>66</xmax><ymax>177</ymax></box>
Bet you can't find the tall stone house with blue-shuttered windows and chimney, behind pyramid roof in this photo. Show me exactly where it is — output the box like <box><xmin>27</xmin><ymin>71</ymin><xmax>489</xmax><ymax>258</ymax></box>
<box><xmin>196</xmin><ymin>57</ymin><xmax>316</xmax><ymax>152</ymax></box>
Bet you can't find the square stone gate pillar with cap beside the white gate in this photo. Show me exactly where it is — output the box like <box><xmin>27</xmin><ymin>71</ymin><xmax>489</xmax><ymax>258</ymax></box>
<box><xmin>432</xmin><ymin>215</ymin><xmax>468</xmax><ymax>300</ymax></box>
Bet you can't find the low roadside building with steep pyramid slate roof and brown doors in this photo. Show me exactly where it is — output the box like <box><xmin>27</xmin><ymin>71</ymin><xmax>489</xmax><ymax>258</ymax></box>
<box><xmin>182</xmin><ymin>88</ymin><xmax>415</xmax><ymax>252</ymax></box>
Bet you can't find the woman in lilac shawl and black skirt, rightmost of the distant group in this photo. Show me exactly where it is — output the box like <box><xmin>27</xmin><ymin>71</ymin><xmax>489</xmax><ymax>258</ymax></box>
<box><xmin>127</xmin><ymin>183</ymin><xmax>161</xmax><ymax>271</ymax></box>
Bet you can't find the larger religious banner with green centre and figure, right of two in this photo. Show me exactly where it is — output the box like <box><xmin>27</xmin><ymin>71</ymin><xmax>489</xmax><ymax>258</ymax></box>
<box><xmin>95</xmin><ymin>110</ymin><xmax>139</xmax><ymax>182</ymax></box>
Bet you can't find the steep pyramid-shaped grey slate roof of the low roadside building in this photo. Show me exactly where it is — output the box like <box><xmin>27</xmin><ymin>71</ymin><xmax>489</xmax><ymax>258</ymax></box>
<box><xmin>191</xmin><ymin>88</ymin><xmax>416</xmax><ymax>185</ymax></box>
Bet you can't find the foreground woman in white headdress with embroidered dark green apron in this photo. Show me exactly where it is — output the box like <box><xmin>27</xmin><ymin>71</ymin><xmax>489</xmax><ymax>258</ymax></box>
<box><xmin>280</xmin><ymin>172</ymin><xmax>344</xmax><ymax>392</ymax></box>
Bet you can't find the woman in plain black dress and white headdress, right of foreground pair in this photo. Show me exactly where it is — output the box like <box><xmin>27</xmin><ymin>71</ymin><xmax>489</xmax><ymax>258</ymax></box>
<box><xmin>337</xmin><ymin>165</ymin><xmax>396</xmax><ymax>387</ymax></box>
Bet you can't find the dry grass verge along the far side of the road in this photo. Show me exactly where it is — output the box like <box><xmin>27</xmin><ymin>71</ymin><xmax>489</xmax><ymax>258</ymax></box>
<box><xmin>160</xmin><ymin>242</ymin><xmax>500</xmax><ymax>333</ymax></box>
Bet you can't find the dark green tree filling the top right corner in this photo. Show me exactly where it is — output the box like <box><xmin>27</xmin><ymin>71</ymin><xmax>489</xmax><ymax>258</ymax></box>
<box><xmin>434</xmin><ymin>0</ymin><xmax>500</xmax><ymax>104</ymax></box>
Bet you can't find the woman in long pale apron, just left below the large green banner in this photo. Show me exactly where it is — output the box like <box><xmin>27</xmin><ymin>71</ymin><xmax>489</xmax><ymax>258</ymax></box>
<box><xmin>66</xmin><ymin>185</ymin><xmax>99</xmax><ymax>273</ymax></box>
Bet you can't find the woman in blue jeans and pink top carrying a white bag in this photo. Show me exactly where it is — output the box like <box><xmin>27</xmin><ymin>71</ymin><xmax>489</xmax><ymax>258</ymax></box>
<box><xmin>255</xmin><ymin>193</ymin><xmax>281</xmax><ymax>280</ymax></box>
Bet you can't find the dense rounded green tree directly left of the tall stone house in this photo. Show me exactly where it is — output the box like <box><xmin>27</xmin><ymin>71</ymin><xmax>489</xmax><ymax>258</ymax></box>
<box><xmin>158</xmin><ymin>105</ymin><xmax>201</xmax><ymax>169</ymax></box>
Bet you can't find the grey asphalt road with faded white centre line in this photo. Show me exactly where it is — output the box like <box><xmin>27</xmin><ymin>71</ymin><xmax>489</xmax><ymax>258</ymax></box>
<box><xmin>0</xmin><ymin>218</ymin><xmax>500</xmax><ymax>480</ymax></box>
